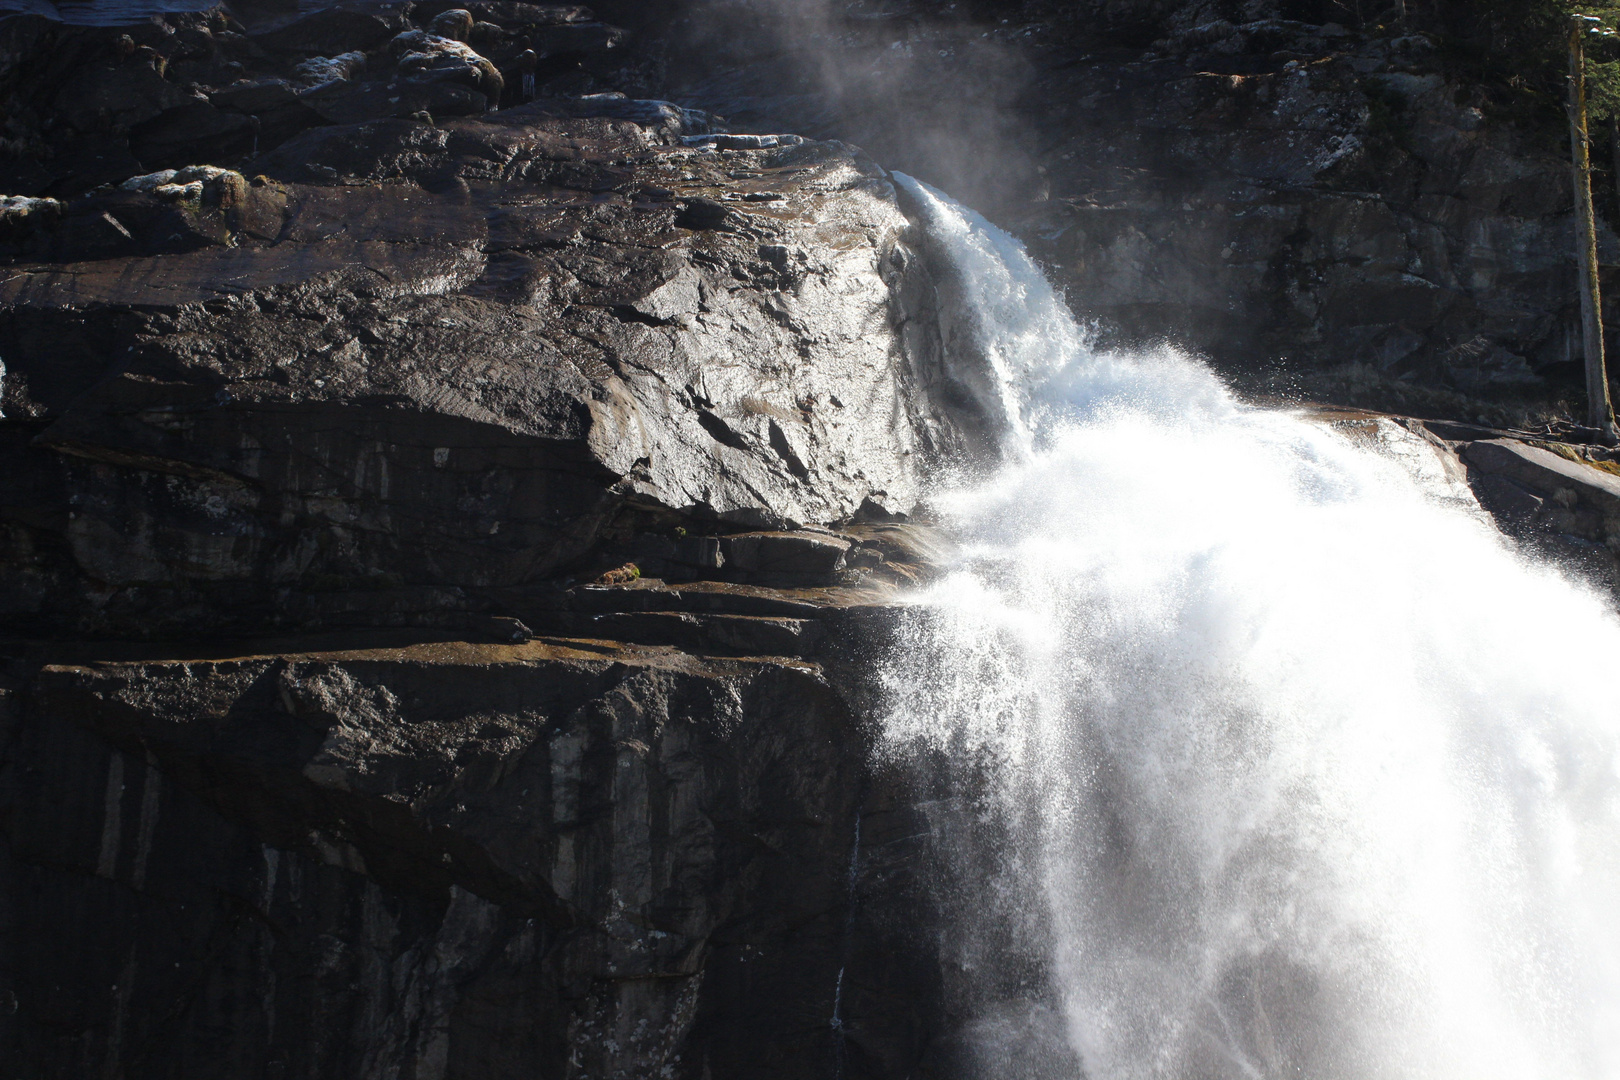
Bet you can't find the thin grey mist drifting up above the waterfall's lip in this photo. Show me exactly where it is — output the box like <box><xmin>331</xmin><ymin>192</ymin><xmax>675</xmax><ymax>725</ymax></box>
<box><xmin>654</xmin><ymin>0</ymin><xmax>1048</xmax><ymax>217</ymax></box>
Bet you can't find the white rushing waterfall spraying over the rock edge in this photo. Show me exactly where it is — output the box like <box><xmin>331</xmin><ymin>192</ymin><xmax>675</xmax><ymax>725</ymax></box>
<box><xmin>886</xmin><ymin>176</ymin><xmax>1620</xmax><ymax>1080</ymax></box>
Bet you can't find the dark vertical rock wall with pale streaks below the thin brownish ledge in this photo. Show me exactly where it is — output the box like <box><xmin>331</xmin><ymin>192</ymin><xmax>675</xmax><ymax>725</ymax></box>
<box><xmin>0</xmin><ymin>643</ymin><xmax>928</xmax><ymax>1080</ymax></box>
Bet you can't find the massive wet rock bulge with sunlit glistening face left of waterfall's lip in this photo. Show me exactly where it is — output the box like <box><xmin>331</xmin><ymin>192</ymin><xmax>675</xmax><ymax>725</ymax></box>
<box><xmin>0</xmin><ymin>107</ymin><xmax>966</xmax><ymax>635</ymax></box>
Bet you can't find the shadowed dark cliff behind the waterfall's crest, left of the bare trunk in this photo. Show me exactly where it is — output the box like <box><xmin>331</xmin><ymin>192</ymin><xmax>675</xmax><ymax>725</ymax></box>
<box><xmin>664</xmin><ymin>0</ymin><xmax>1620</xmax><ymax>426</ymax></box>
